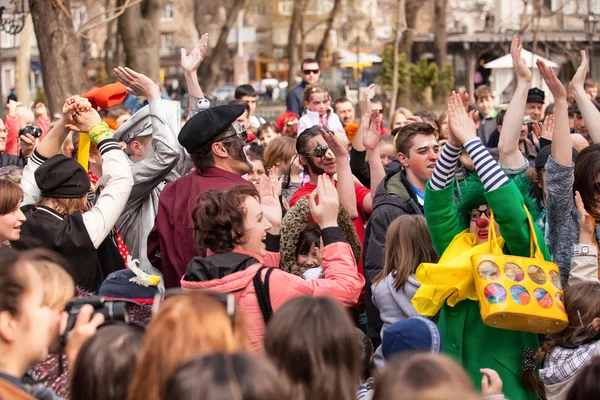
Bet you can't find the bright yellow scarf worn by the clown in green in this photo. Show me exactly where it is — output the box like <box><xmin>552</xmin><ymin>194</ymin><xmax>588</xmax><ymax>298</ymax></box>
<box><xmin>412</xmin><ymin>230</ymin><xmax>504</xmax><ymax>316</ymax></box>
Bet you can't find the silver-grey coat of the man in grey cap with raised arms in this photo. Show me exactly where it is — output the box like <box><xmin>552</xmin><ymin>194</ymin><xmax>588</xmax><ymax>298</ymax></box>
<box><xmin>117</xmin><ymin>100</ymin><xmax>182</xmax><ymax>274</ymax></box>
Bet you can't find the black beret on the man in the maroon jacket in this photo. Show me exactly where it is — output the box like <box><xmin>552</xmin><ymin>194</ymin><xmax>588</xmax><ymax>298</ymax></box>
<box><xmin>178</xmin><ymin>104</ymin><xmax>246</xmax><ymax>153</ymax></box>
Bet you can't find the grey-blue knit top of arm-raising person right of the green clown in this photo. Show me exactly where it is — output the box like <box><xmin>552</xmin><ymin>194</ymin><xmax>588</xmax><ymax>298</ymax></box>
<box><xmin>546</xmin><ymin>156</ymin><xmax>600</xmax><ymax>287</ymax></box>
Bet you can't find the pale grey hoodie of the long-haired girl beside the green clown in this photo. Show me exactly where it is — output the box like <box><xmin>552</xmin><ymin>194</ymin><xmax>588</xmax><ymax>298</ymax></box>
<box><xmin>371</xmin><ymin>274</ymin><xmax>421</xmax><ymax>369</ymax></box>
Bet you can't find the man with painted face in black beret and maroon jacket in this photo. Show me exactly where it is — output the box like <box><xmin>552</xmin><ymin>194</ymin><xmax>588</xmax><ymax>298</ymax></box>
<box><xmin>148</xmin><ymin>104</ymin><xmax>252</xmax><ymax>288</ymax></box>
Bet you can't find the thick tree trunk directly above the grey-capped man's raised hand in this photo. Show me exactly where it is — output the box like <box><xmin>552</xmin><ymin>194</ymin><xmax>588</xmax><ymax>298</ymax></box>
<box><xmin>118</xmin><ymin>0</ymin><xmax>162</xmax><ymax>82</ymax></box>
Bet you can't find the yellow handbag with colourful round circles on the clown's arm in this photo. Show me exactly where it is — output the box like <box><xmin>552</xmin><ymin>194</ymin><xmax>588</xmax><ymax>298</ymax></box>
<box><xmin>471</xmin><ymin>206</ymin><xmax>569</xmax><ymax>334</ymax></box>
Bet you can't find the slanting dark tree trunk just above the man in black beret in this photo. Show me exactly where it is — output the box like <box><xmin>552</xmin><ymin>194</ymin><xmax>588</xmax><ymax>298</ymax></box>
<box><xmin>199</xmin><ymin>0</ymin><xmax>247</xmax><ymax>93</ymax></box>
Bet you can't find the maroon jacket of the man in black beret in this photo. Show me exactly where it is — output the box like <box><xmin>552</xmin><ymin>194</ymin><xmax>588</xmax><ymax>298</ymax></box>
<box><xmin>148</xmin><ymin>168</ymin><xmax>251</xmax><ymax>288</ymax></box>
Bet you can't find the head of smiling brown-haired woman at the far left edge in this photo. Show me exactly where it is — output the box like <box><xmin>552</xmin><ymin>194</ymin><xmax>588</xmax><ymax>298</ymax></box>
<box><xmin>0</xmin><ymin>179</ymin><xmax>25</xmax><ymax>243</ymax></box>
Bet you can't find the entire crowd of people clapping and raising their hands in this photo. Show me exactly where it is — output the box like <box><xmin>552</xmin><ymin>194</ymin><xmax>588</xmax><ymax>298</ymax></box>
<box><xmin>0</xmin><ymin>35</ymin><xmax>600</xmax><ymax>400</ymax></box>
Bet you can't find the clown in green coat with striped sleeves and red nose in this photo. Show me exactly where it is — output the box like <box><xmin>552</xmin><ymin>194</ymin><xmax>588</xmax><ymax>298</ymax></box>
<box><xmin>413</xmin><ymin>93</ymin><xmax>551</xmax><ymax>400</ymax></box>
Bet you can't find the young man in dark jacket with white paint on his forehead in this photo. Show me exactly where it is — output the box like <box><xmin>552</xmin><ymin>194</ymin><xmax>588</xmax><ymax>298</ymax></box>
<box><xmin>363</xmin><ymin>122</ymin><xmax>440</xmax><ymax>346</ymax></box>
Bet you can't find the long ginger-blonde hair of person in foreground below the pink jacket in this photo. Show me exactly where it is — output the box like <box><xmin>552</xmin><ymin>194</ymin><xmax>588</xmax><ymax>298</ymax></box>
<box><xmin>127</xmin><ymin>291</ymin><xmax>248</xmax><ymax>400</ymax></box>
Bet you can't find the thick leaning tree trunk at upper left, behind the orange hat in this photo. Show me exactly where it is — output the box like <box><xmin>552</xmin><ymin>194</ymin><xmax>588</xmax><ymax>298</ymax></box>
<box><xmin>29</xmin><ymin>0</ymin><xmax>86</xmax><ymax>115</ymax></box>
